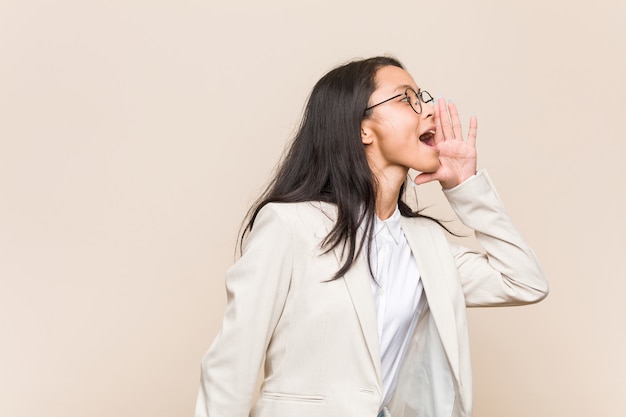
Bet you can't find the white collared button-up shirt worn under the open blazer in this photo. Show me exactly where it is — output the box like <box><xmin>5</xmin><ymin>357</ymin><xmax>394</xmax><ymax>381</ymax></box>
<box><xmin>370</xmin><ymin>207</ymin><xmax>426</xmax><ymax>408</ymax></box>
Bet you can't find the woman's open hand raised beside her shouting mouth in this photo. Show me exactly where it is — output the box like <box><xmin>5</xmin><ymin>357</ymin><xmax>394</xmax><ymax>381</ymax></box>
<box><xmin>414</xmin><ymin>98</ymin><xmax>478</xmax><ymax>188</ymax></box>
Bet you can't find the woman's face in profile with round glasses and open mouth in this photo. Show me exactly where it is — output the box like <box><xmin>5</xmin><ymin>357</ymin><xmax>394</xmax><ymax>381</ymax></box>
<box><xmin>361</xmin><ymin>66</ymin><xmax>439</xmax><ymax>178</ymax></box>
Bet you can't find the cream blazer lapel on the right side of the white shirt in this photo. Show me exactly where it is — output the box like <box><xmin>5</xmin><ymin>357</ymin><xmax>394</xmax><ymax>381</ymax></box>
<box><xmin>402</xmin><ymin>217</ymin><xmax>460</xmax><ymax>382</ymax></box>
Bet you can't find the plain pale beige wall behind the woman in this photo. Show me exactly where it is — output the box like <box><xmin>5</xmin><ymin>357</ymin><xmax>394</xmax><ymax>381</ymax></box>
<box><xmin>0</xmin><ymin>0</ymin><xmax>626</xmax><ymax>417</ymax></box>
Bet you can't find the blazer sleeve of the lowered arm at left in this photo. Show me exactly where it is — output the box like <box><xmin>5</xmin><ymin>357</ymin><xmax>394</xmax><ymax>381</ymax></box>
<box><xmin>195</xmin><ymin>204</ymin><xmax>293</xmax><ymax>417</ymax></box>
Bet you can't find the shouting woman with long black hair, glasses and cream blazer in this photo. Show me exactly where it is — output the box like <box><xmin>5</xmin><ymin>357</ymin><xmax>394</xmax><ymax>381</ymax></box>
<box><xmin>196</xmin><ymin>57</ymin><xmax>547</xmax><ymax>417</ymax></box>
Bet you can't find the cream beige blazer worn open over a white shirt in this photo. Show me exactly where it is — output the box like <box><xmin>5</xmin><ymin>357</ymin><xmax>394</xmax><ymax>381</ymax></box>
<box><xmin>196</xmin><ymin>172</ymin><xmax>548</xmax><ymax>417</ymax></box>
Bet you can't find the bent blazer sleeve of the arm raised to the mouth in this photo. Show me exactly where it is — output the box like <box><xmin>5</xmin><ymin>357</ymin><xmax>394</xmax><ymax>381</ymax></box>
<box><xmin>444</xmin><ymin>170</ymin><xmax>548</xmax><ymax>307</ymax></box>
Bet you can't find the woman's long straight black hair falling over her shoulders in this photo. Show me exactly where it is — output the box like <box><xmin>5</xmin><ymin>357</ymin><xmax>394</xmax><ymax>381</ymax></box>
<box><xmin>240</xmin><ymin>56</ymin><xmax>436</xmax><ymax>279</ymax></box>
